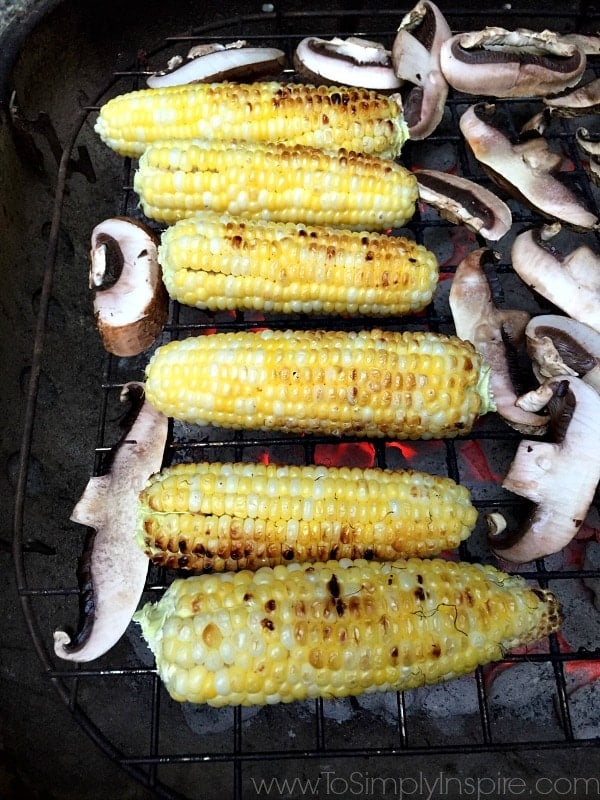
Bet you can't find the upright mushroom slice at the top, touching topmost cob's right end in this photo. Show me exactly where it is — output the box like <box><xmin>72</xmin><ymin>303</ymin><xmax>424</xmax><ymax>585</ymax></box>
<box><xmin>392</xmin><ymin>0</ymin><xmax>452</xmax><ymax>139</ymax></box>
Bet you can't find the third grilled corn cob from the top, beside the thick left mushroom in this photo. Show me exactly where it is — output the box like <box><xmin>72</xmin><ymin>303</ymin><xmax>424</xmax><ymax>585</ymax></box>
<box><xmin>159</xmin><ymin>212</ymin><xmax>438</xmax><ymax>315</ymax></box>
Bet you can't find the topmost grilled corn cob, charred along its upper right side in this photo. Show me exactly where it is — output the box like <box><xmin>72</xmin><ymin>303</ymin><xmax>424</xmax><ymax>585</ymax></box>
<box><xmin>95</xmin><ymin>81</ymin><xmax>408</xmax><ymax>158</ymax></box>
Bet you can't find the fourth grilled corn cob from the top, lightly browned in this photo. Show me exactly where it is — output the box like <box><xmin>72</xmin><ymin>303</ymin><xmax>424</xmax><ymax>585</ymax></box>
<box><xmin>146</xmin><ymin>330</ymin><xmax>493</xmax><ymax>439</ymax></box>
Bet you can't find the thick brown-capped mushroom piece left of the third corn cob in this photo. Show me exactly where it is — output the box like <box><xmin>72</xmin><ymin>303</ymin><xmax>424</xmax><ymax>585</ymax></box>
<box><xmin>90</xmin><ymin>217</ymin><xmax>169</xmax><ymax>356</ymax></box>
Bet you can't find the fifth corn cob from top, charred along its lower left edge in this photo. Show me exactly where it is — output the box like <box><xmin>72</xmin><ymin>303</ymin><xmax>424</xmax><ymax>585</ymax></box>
<box><xmin>137</xmin><ymin>462</ymin><xmax>477</xmax><ymax>571</ymax></box>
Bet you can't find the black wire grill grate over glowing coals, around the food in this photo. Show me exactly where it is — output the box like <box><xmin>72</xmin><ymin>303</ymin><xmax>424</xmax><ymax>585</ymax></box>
<box><xmin>15</xmin><ymin>3</ymin><xmax>600</xmax><ymax>800</ymax></box>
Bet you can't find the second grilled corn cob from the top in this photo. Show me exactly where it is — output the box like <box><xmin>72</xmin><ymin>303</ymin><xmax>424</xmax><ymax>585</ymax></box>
<box><xmin>133</xmin><ymin>139</ymin><xmax>418</xmax><ymax>230</ymax></box>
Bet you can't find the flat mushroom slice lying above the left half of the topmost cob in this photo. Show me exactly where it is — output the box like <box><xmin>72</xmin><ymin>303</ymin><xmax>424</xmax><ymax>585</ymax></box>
<box><xmin>146</xmin><ymin>40</ymin><xmax>286</xmax><ymax>89</ymax></box>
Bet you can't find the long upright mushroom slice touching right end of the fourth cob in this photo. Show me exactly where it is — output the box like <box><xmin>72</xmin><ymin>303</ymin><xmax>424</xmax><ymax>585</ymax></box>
<box><xmin>449</xmin><ymin>247</ymin><xmax>548</xmax><ymax>434</ymax></box>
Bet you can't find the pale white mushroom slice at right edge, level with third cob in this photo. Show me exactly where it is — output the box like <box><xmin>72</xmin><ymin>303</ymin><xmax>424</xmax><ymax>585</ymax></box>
<box><xmin>511</xmin><ymin>224</ymin><xmax>600</xmax><ymax>331</ymax></box>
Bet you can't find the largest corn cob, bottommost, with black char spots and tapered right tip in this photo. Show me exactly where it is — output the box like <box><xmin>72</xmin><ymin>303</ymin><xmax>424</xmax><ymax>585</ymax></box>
<box><xmin>134</xmin><ymin>558</ymin><xmax>560</xmax><ymax>706</ymax></box>
